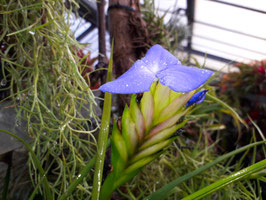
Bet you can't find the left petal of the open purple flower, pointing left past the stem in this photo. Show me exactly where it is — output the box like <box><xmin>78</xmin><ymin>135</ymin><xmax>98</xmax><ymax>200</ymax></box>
<box><xmin>99</xmin><ymin>60</ymin><xmax>156</xmax><ymax>94</ymax></box>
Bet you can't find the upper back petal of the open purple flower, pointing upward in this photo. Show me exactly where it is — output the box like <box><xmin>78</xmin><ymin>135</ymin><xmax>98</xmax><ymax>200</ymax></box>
<box><xmin>142</xmin><ymin>44</ymin><xmax>181</xmax><ymax>74</ymax></box>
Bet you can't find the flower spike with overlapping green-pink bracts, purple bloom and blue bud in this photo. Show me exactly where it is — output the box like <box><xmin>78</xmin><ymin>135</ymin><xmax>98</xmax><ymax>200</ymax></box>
<box><xmin>97</xmin><ymin>45</ymin><xmax>212</xmax><ymax>200</ymax></box>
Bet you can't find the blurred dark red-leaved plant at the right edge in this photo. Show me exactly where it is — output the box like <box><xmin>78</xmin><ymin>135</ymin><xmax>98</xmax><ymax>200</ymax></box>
<box><xmin>218</xmin><ymin>60</ymin><xmax>266</xmax><ymax>136</ymax></box>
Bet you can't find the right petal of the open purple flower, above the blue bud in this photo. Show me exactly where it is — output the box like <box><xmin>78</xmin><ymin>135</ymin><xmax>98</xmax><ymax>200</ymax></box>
<box><xmin>156</xmin><ymin>65</ymin><xmax>213</xmax><ymax>92</ymax></box>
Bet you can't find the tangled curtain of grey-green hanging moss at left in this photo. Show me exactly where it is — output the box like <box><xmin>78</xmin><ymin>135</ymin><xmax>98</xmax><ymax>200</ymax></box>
<box><xmin>0</xmin><ymin>0</ymin><xmax>98</xmax><ymax>199</ymax></box>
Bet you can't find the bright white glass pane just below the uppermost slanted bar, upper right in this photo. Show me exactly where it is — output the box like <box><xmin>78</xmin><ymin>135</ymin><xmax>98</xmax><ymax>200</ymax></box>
<box><xmin>195</xmin><ymin>0</ymin><xmax>266</xmax><ymax>39</ymax></box>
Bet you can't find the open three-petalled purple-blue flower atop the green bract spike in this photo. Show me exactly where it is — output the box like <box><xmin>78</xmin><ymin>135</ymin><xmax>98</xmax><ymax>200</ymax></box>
<box><xmin>99</xmin><ymin>44</ymin><xmax>212</xmax><ymax>94</ymax></box>
